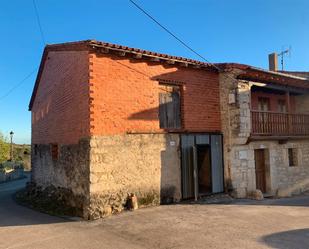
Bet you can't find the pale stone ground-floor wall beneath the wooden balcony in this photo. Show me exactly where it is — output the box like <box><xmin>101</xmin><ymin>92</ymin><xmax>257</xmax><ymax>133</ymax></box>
<box><xmin>230</xmin><ymin>141</ymin><xmax>309</xmax><ymax>197</ymax></box>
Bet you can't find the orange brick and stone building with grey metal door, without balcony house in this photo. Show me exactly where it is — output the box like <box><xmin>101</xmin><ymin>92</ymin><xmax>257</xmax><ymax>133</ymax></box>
<box><xmin>29</xmin><ymin>41</ymin><xmax>224</xmax><ymax>219</ymax></box>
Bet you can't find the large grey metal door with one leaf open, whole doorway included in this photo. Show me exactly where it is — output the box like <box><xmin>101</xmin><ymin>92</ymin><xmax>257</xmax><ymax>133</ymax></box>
<box><xmin>181</xmin><ymin>134</ymin><xmax>224</xmax><ymax>200</ymax></box>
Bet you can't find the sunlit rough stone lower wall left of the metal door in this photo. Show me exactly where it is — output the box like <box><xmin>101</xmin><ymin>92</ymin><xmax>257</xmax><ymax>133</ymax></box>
<box><xmin>89</xmin><ymin>134</ymin><xmax>181</xmax><ymax>219</ymax></box>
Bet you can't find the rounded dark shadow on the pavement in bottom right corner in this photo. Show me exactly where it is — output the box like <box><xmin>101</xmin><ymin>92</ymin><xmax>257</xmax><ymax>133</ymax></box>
<box><xmin>262</xmin><ymin>228</ymin><xmax>309</xmax><ymax>249</ymax></box>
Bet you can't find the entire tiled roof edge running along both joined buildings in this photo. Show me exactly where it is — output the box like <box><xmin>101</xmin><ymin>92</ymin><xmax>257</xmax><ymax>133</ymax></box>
<box><xmin>29</xmin><ymin>40</ymin><xmax>309</xmax><ymax>110</ymax></box>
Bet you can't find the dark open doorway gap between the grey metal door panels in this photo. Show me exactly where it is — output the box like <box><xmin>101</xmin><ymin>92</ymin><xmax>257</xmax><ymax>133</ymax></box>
<box><xmin>197</xmin><ymin>145</ymin><xmax>212</xmax><ymax>195</ymax></box>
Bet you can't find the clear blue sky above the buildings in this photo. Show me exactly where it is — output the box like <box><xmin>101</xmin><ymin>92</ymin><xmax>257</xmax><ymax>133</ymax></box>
<box><xmin>0</xmin><ymin>0</ymin><xmax>309</xmax><ymax>143</ymax></box>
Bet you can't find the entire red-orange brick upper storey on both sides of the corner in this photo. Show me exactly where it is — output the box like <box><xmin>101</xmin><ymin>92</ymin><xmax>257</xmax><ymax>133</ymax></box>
<box><xmin>32</xmin><ymin>48</ymin><xmax>221</xmax><ymax>144</ymax></box>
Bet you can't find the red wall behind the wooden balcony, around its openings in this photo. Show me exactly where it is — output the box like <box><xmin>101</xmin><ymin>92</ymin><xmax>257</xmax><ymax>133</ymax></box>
<box><xmin>251</xmin><ymin>92</ymin><xmax>295</xmax><ymax>112</ymax></box>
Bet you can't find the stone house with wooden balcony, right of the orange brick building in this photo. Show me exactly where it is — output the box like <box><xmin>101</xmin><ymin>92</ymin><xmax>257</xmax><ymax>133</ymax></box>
<box><xmin>217</xmin><ymin>63</ymin><xmax>309</xmax><ymax>198</ymax></box>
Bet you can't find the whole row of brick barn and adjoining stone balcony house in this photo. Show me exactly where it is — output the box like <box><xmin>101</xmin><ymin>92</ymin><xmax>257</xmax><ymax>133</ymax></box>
<box><xmin>29</xmin><ymin>40</ymin><xmax>309</xmax><ymax>219</ymax></box>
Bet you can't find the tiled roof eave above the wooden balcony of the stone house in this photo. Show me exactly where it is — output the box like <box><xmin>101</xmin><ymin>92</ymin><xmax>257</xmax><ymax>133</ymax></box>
<box><xmin>215</xmin><ymin>63</ymin><xmax>309</xmax><ymax>89</ymax></box>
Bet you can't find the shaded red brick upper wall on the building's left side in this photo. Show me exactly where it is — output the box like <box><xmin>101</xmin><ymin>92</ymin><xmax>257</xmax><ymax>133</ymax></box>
<box><xmin>32</xmin><ymin>51</ymin><xmax>90</xmax><ymax>144</ymax></box>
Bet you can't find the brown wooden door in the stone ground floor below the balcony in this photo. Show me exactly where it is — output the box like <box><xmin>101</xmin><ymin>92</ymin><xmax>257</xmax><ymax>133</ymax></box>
<box><xmin>254</xmin><ymin>149</ymin><xmax>266</xmax><ymax>193</ymax></box>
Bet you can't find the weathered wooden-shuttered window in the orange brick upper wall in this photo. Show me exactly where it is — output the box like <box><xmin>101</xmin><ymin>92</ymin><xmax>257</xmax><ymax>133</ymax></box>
<box><xmin>159</xmin><ymin>85</ymin><xmax>181</xmax><ymax>129</ymax></box>
